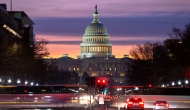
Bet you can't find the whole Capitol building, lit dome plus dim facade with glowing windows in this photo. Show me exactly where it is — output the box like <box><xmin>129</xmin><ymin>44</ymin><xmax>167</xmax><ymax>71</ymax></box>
<box><xmin>54</xmin><ymin>6</ymin><xmax>131</xmax><ymax>85</ymax></box>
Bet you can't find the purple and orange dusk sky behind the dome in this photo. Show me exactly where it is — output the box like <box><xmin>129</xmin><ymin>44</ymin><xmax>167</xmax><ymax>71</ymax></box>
<box><xmin>0</xmin><ymin>0</ymin><xmax>190</xmax><ymax>58</ymax></box>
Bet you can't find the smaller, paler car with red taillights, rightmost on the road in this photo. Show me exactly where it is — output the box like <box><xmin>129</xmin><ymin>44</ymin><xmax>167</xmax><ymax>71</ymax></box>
<box><xmin>153</xmin><ymin>101</ymin><xmax>169</xmax><ymax>110</ymax></box>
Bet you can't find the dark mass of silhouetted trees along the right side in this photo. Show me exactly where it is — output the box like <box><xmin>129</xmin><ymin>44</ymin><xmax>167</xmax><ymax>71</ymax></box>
<box><xmin>126</xmin><ymin>23</ymin><xmax>190</xmax><ymax>86</ymax></box>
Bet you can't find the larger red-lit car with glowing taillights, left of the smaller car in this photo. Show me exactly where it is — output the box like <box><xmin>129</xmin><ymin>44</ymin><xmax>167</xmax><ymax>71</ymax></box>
<box><xmin>124</xmin><ymin>97</ymin><xmax>144</xmax><ymax>110</ymax></box>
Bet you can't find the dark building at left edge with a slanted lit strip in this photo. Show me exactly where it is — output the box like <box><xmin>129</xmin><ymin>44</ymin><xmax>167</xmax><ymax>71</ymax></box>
<box><xmin>0</xmin><ymin>4</ymin><xmax>35</xmax><ymax>82</ymax></box>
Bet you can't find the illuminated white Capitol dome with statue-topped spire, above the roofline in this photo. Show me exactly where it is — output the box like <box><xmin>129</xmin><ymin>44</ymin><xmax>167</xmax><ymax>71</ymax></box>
<box><xmin>78</xmin><ymin>5</ymin><xmax>114</xmax><ymax>59</ymax></box>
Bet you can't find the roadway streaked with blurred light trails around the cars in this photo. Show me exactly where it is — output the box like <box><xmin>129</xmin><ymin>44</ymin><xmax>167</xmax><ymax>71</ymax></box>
<box><xmin>0</xmin><ymin>93</ymin><xmax>190</xmax><ymax>110</ymax></box>
